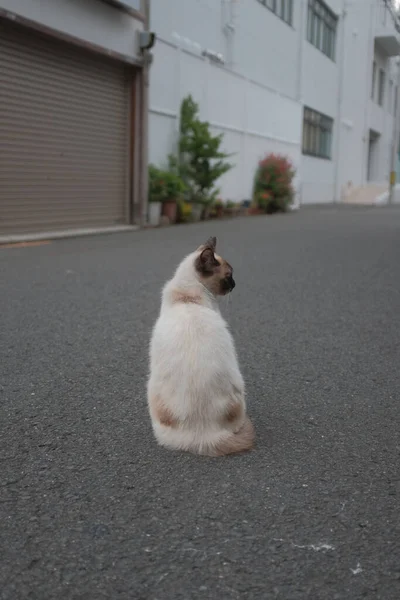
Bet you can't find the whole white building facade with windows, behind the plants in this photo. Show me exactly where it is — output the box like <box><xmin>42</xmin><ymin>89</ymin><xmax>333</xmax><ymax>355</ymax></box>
<box><xmin>149</xmin><ymin>0</ymin><xmax>400</xmax><ymax>204</ymax></box>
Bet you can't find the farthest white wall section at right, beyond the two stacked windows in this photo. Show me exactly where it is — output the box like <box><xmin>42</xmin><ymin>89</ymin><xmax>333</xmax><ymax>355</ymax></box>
<box><xmin>339</xmin><ymin>0</ymin><xmax>397</xmax><ymax>195</ymax></box>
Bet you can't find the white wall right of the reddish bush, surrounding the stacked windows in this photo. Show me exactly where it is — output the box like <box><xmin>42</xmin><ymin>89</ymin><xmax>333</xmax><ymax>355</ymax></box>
<box><xmin>302</xmin><ymin>0</ymin><xmax>397</xmax><ymax>203</ymax></box>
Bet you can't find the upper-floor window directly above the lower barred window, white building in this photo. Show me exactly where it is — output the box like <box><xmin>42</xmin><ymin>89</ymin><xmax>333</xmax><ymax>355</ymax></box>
<box><xmin>307</xmin><ymin>0</ymin><xmax>337</xmax><ymax>60</ymax></box>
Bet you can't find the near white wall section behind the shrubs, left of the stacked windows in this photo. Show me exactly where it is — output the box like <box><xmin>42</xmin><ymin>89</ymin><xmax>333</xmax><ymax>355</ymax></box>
<box><xmin>150</xmin><ymin>0</ymin><xmax>302</xmax><ymax>201</ymax></box>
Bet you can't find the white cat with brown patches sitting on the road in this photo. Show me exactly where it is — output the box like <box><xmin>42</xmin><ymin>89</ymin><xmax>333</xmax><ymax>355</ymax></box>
<box><xmin>147</xmin><ymin>237</ymin><xmax>254</xmax><ymax>456</ymax></box>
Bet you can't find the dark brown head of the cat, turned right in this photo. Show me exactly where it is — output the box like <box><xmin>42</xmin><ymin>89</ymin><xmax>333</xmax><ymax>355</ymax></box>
<box><xmin>194</xmin><ymin>237</ymin><xmax>236</xmax><ymax>296</ymax></box>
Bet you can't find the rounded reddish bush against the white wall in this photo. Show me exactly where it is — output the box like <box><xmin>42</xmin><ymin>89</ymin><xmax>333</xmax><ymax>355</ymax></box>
<box><xmin>253</xmin><ymin>154</ymin><xmax>295</xmax><ymax>213</ymax></box>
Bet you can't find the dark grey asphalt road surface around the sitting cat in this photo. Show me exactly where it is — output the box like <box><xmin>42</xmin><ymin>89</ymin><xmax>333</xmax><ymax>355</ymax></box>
<box><xmin>0</xmin><ymin>207</ymin><xmax>400</xmax><ymax>600</ymax></box>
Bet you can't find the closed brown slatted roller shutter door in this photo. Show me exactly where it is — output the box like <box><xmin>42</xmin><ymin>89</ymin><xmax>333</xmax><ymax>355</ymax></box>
<box><xmin>0</xmin><ymin>22</ymin><xmax>130</xmax><ymax>235</ymax></box>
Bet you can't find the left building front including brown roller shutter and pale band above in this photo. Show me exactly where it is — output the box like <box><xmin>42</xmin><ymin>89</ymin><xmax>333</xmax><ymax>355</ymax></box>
<box><xmin>0</xmin><ymin>0</ymin><xmax>146</xmax><ymax>239</ymax></box>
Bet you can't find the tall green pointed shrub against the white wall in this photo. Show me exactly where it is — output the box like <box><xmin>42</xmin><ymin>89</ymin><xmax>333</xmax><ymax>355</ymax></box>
<box><xmin>177</xmin><ymin>95</ymin><xmax>233</xmax><ymax>204</ymax></box>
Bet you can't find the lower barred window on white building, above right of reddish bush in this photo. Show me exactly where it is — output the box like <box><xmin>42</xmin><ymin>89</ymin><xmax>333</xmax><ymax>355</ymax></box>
<box><xmin>303</xmin><ymin>106</ymin><xmax>333</xmax><ymax>159</ymax></box>
